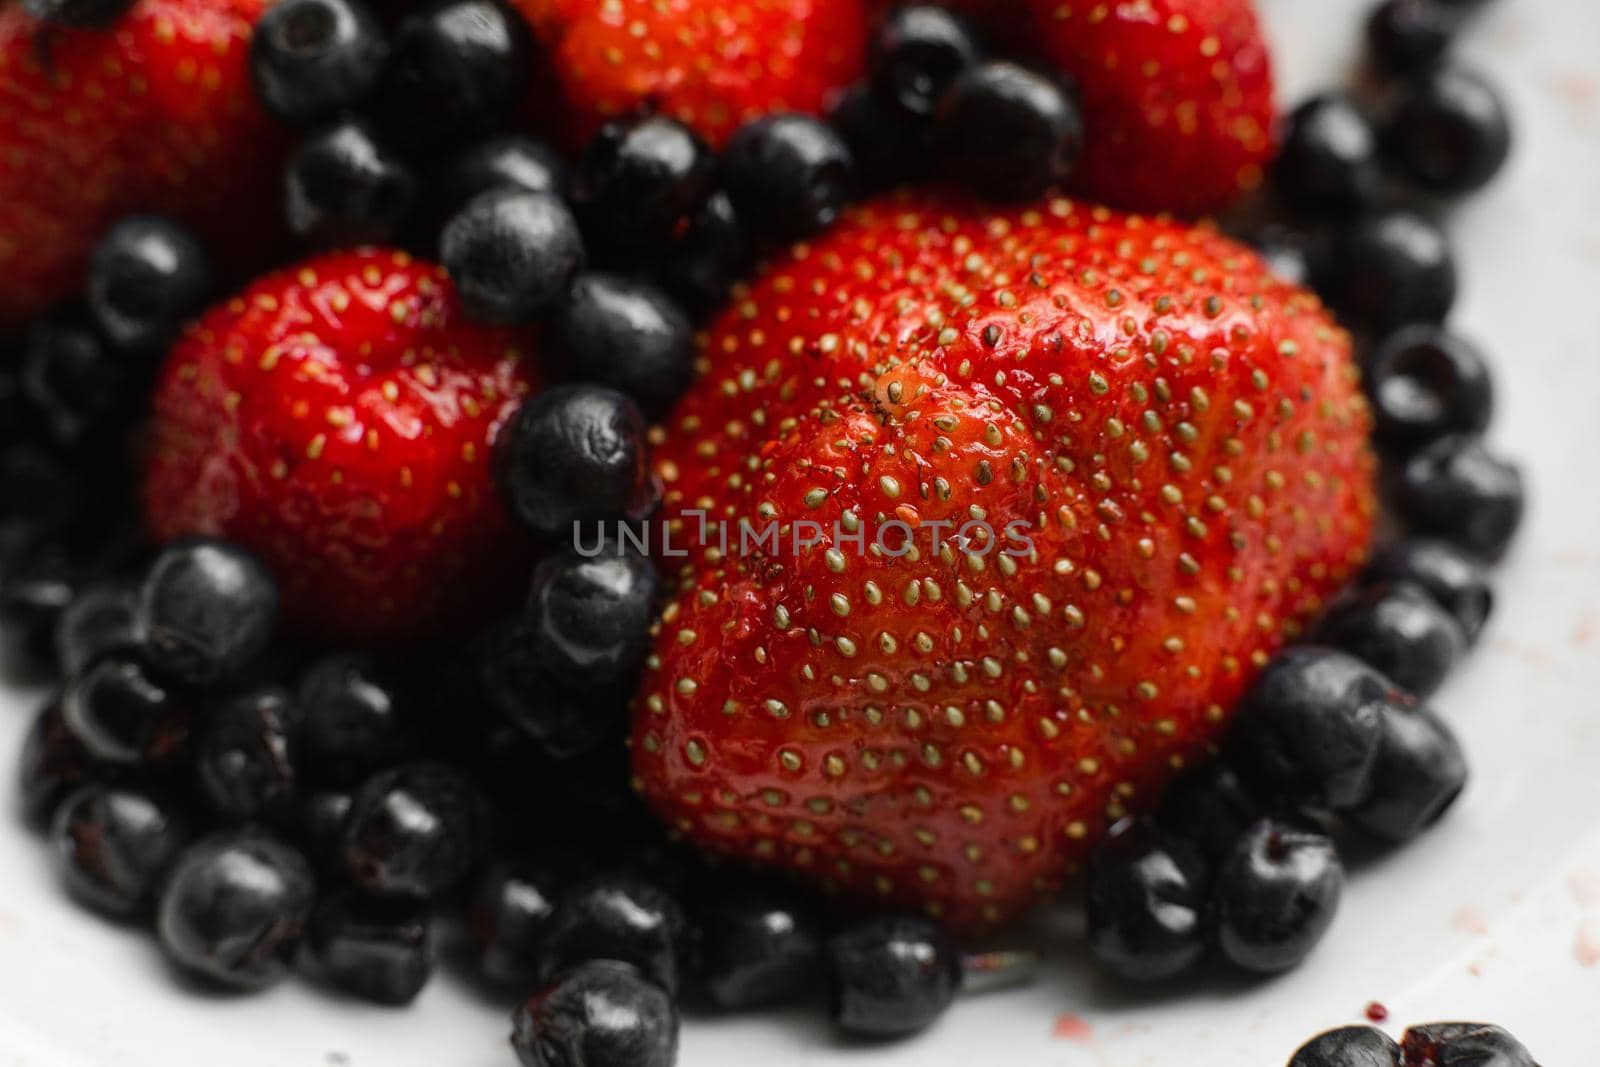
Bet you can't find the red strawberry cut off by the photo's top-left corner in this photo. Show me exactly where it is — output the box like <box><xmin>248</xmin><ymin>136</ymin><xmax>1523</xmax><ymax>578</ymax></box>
<box><xmin>0</xmin><ymin>0</ymin><xmax>286</xmax><ymax>330</ymax></box>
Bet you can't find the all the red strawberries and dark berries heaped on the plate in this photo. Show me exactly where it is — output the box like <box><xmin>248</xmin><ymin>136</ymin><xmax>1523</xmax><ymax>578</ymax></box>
<box><xmin>0</xmin><ymin>0</ymin><xmax>1528</xmax><ymax>1067</ymax></box>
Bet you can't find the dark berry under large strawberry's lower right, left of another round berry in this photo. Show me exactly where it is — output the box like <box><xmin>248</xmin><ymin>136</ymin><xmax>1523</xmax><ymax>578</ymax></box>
<box><xmin>1086</xmin><ymin>819</ymin><xmax>1206</xmax><ymax>982</ymax></box>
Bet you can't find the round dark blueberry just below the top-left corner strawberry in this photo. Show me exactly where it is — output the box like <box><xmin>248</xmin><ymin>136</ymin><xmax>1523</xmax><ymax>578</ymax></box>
<box><xmin>88</xmin><ymin>216</ymin><xmax>216</xmax><ymax>352</ymax></box>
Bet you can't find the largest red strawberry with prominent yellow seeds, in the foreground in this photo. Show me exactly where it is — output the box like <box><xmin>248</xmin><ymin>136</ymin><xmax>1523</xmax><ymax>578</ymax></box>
<box><xmin>632</xmin><ymin>197</ymin><xmax>1374</xmax><ymax>928</ymax></box>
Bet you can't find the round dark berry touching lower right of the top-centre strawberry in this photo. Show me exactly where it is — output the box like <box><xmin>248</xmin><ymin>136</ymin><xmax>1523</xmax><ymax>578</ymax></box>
<box><xmin>722</xmin><ymin>114</ymin><xmax>856</xmax><ymax>242</ymax></box>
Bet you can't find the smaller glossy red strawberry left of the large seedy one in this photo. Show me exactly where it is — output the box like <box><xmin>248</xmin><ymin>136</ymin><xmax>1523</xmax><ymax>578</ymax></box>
<box><xmin>144</xmin><ymin>250</ymin><xmax>533</xmax><ymax>643</ymax></box>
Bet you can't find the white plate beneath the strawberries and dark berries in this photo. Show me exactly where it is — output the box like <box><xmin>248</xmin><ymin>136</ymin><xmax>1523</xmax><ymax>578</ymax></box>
<box><xmin>0</xmin><ymin>0</ymin><xmax>1600</xmax><ymax>1067</ymax></box>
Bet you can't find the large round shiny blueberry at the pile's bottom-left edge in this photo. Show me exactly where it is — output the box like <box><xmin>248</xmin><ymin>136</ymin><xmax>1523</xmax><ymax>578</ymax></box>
<box><xmin>157</xmin><ymin>830</ymin><xmax>315</xmax><ymax>989</ymax></box>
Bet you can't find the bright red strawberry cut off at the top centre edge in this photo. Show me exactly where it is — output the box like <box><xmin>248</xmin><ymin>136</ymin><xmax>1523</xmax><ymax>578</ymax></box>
<box><xmin>512</xmin><ymin>0</ymin><xmax>867</xmax><ymax>147</ymax></box>
